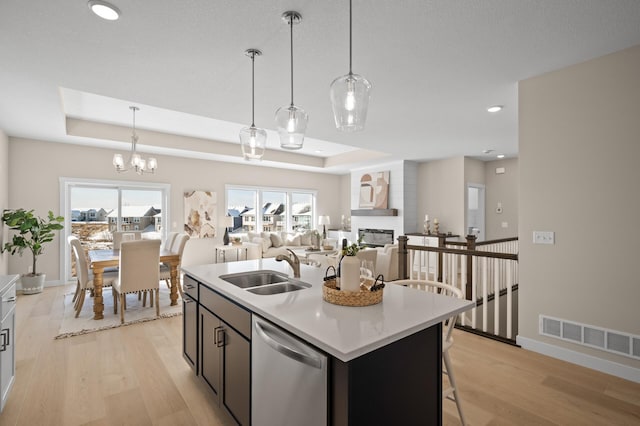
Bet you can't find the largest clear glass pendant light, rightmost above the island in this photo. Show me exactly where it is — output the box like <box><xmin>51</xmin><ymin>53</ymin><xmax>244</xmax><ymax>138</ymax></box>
<box><xmin>329</xmin><ymin>0</ymin><xmax>371</xmax><ymax>132</ymax></box>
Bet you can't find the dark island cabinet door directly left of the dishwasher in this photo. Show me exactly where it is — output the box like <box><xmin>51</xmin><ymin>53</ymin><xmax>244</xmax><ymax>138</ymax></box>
<box><xmin>223</xmin><ymin>326</ymin><xmax>251</xmax><ymax>425</ymax></box>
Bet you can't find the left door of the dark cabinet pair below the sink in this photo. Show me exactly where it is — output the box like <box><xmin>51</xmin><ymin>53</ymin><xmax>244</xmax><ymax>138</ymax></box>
<box><xmin>200</xmin><ymin>309</ymin><xmax>222</xmax><ymax>398</ymax></box>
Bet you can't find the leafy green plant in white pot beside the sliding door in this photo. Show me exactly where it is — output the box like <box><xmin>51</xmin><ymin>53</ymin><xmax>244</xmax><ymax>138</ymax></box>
<box><xmin>0</xmin><ymin>209</ymin><xmax>64</xmax><ymax>294</ymax></box>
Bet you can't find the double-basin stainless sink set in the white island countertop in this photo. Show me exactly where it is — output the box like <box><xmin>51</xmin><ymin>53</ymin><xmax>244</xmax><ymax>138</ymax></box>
<box><xmin>219</xmin><ymin>270</ymin><xmax>311</xmax><ymax>295</ymax></box>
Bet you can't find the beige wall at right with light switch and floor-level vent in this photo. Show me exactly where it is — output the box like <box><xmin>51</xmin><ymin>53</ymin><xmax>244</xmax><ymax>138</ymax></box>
<box><xmin>519</xmin><ymin>46</ymin><xmax>640</xmax><ymax>368</ymax></box>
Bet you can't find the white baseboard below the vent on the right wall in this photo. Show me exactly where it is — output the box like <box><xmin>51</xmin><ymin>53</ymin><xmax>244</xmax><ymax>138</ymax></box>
<box><xmin>516</xmin><ymin>336</ymin><xmax>640</xmax><ymax>383</ymax></box>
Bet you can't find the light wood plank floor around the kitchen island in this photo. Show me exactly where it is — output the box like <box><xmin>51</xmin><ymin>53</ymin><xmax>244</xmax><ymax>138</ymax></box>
<box><xmin>0</xmin><ymin>287</ymin><xmax>640</xmax><ymax>426</ymax></box>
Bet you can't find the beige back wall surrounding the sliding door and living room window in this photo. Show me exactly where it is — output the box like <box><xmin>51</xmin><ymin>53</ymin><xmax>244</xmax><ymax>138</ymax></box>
<box><xmin>6</xmin><ymin>138</ymin><xmax>342</xmax><ymax>281</ymax></box>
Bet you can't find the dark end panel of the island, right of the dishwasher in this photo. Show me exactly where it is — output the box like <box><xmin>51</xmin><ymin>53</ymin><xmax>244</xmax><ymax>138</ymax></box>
<box><xmin>329</xmin><ymin>324</ymin><xmax>442</xmax><ymax>426</ymax></box>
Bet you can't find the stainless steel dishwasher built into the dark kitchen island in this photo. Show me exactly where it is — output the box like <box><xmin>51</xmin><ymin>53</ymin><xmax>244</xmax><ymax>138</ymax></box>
<box><xmin>251</xmin><ymin>315</ymin><xmax>327</xmax><ymax>426</ymax></box>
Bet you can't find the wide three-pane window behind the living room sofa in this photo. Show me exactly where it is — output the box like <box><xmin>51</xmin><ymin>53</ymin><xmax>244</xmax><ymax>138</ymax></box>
<box><xmin>226</xmin><ymin>185</ymin><xmax>316</xmax><ymax>232</ymax></box>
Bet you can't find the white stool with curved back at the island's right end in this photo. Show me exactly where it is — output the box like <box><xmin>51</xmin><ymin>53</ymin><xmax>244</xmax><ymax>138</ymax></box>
<box><xmin>393</xmin><ymin>280</ymin><xmax>466</xmax><ymax>426</ymax></box>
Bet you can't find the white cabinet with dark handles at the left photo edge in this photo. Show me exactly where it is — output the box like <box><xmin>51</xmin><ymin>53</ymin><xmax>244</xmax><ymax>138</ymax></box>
<box><xmin>0</xmin><ymin>275</ymin><xmax>18</xmax><ymax>412</ymax></box>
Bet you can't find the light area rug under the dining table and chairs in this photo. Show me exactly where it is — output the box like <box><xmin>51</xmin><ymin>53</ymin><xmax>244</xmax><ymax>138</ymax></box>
<box><xmin>55</xmin><ymin>282</ymin><xmax>182</xmax><ymax>339</ymax></box>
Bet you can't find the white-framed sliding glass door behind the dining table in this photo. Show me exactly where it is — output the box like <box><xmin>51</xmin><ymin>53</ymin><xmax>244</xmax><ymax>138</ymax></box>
<box><xmin>60</xmin><ymin>178</ymin><xmax>171</xmax><ymax>280</ymax></box>
